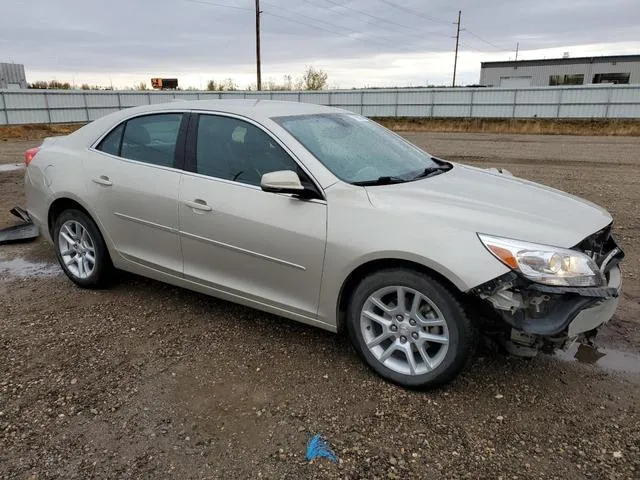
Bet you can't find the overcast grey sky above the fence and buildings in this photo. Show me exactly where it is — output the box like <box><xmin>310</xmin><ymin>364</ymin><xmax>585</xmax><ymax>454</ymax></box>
<box><xmin>0</xmin><ymin>0</ymin><xmax>640</xmax><ymax>88</ymax></box>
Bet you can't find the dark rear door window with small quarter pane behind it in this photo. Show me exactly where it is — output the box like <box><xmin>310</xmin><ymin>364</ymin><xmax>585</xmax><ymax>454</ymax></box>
<box><xmin>114</xmin><ymin>113</ymin><xmax>182</xmax><ymax>167</ymax></box>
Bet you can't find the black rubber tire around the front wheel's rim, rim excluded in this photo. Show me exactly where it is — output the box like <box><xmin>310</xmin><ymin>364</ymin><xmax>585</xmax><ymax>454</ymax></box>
<box><xmin>347</xmin><ymin>268</ymin><xmax>476</xmax><ymax>390</ymax></box>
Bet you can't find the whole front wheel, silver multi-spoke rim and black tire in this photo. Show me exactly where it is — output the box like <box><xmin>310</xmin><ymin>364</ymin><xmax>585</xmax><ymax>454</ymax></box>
<box><xmin>347</xmin><ymin>268</ymin><xmax>476</xmax><ymax>389</ymax></box>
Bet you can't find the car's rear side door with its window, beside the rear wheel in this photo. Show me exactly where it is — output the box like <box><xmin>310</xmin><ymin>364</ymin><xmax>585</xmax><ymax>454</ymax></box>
<box><xmin>84</xmin><ymin>112</ymin><xmax>187</xmax><ymax>276</ymax></box>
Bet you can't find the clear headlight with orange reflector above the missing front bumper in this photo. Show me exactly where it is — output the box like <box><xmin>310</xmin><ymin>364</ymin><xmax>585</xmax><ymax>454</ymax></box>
<box><xmin>478</xmin><ymin>234</ymin><xmax>605</xmax><ymax>287</ymax></box>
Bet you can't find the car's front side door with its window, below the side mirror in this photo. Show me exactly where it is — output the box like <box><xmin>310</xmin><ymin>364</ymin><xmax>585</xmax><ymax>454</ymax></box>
<box><xmin>179</xmin><ymin>114</ymin><xmax>327</xmax><ymax>318</ymax></box>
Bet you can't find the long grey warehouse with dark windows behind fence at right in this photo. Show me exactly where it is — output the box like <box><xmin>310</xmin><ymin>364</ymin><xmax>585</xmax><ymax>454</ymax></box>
<box><xmin>480</xmin><ymin>54</ymin><xmax>640</xmax><ymax>88</ymax></box>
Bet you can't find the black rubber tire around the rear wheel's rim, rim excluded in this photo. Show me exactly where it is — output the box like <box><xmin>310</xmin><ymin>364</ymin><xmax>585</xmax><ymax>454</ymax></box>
<box><xmin>53</xmin><ymin>209</ymin><xmax>113</xmax><ymax>289</ymax></box>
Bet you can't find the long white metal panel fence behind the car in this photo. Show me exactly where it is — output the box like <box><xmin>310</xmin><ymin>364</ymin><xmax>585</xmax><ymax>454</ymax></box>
<box><xmin>0</xmin><ymin>85</ymin><xmax>640</xmax><ymax>125</ymax></box>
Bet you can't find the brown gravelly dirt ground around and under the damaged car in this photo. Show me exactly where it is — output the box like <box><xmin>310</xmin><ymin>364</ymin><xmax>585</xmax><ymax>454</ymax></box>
<box><xmin>0</xmin><ymin>132</ymin><xmax>640</xmax><ymax>480</ymax></box>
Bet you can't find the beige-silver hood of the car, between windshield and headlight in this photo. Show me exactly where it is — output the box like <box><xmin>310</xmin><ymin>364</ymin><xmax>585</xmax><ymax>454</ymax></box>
<box><xmin>367</xmin><ymin>164</ymin><xmax>611</xmax><ymax>247</ymax></box>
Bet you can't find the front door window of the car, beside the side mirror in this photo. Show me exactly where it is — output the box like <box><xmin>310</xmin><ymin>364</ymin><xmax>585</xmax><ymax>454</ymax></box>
<box><xmin>196</xmin><ymin>115</ymin><xmax>304</xmax><ymax>185</ymax></box>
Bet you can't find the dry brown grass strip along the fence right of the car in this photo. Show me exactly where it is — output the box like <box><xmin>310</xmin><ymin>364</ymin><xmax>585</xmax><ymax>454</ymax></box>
<box><xmin>373</xmin><ymin>117</ymin><xmax>640</xmax><ymax>137</ymax></box>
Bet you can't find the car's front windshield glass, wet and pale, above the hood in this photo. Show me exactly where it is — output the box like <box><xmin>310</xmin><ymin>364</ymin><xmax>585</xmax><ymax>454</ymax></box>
<box><xmin>273</xmin><ymin>113</ymin><xmax>442</xmax><ymax>184</ymax></box>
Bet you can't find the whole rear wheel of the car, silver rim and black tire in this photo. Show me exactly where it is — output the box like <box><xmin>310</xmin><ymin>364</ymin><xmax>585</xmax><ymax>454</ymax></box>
<box><xmin>53</xmin><ymin>209</ymin><xmax>113</xmax><ymax>289</ymax></box>
